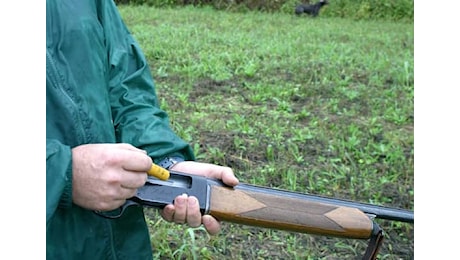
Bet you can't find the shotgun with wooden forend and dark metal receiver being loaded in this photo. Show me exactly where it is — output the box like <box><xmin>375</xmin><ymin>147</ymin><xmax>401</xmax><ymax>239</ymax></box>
<box><xmin>131</xmin><ymin>171</ymin><xmax>414</xmax><ymax>259</ymax></box>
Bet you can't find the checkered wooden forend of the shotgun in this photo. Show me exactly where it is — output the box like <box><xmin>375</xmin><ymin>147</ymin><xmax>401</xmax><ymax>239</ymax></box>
<box><xmin>209</xmin><ymin>186</ymin><xmax>373</xmax><ymax>239</ymax></box>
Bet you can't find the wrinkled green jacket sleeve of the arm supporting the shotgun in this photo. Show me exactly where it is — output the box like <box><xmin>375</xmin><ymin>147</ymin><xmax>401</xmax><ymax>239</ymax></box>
<box><xmin>102</xmin><ymin>1</ymin><xmax>195</xmax><ymax>162</ymax></box>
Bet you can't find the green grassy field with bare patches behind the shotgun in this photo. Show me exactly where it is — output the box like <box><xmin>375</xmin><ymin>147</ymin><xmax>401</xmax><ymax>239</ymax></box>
<box><xmin>120</xmin><ymin>6</ymin><xmax>414</xmax><ymax>259</ymax></box>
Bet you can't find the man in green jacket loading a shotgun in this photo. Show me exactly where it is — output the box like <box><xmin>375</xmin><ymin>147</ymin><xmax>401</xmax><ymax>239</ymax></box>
<box><xmin>46</xmin><ymin>0</ymin><xmax>238</xmax><ymax>259</ymax></box>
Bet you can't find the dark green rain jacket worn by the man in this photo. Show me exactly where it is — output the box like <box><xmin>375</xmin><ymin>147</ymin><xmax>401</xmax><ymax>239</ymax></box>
<box><xmin>46</xmin><ymin>0</ymin><xmax>195</xmax><ymax>260</ymax></box>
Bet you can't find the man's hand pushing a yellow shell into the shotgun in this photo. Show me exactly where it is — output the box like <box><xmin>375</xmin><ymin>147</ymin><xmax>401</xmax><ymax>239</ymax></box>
<box><xmin>72</xmin><ymin>144</ymin><xmax>152</xmax><ymax>211</ymax></box>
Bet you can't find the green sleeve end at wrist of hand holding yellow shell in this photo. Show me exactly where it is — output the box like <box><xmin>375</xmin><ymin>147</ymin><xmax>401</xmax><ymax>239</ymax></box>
<box><xmin>46</xmin><ymin>139</ymin><xmax>72</xmax><ymax>225</ymax></box>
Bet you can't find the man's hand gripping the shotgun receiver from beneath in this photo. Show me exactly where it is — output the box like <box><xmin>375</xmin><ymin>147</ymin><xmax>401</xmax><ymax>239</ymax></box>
<box><xmin>161</xmin><ymin>161</ymin><xmax>239</xmax><ymax>235</ymax></box>
